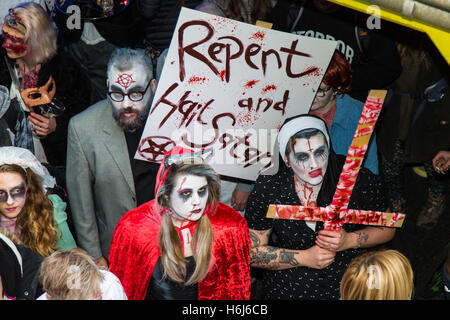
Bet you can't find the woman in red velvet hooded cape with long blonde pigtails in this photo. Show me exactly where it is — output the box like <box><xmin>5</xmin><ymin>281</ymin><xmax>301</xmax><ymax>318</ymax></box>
<box><xmin>109</xmin><ymin>147</ymin><xmax>250</xmax><ymax>300</ymax></box>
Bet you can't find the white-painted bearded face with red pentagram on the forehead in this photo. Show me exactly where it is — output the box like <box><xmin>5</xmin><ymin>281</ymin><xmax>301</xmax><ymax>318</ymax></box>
<box><xmin>108</xmin><ymin>63</ymin><xmax>153</xmax><ymax>130</ymax></box>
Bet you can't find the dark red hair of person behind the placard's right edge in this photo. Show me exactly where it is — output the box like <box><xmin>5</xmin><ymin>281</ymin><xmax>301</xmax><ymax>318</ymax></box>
<box><xmin>322</xmin><ymin>50</ymin><xmax>352</xmax><ymax>94</ymax></box>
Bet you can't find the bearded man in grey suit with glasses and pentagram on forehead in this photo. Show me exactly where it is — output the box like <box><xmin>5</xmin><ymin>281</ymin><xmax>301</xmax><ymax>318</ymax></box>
<box><xmin>66</xmin><ymin>48</ymin><xmax>159</xmax><ymax>268</ymax></box>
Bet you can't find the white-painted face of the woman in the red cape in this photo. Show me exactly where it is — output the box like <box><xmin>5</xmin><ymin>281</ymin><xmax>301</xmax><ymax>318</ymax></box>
<box><xmin>170</xmin><ymin>174</ymin><xmax>208</xmax><ymax>221</ymax></box>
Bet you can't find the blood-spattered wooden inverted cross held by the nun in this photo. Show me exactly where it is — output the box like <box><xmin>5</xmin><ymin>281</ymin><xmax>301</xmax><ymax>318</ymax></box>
<box><xmin>266</xmin><ymin>90</ymin><xmax>405</xmax><ymax>231</ymax></box>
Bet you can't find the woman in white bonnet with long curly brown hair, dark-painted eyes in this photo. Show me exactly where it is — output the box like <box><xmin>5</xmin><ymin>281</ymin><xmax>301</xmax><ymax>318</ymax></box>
<box><xmin>0</xmin><ymin>147</ymin><xmax>76</xmax><ymax>256</ymax></box>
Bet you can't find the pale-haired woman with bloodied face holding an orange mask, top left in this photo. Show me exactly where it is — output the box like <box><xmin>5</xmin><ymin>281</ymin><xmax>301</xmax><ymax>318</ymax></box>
<box><xmin>0</xmin><ymin>2</ymin><xmax>87</xmax><ymax>170</ymax></box>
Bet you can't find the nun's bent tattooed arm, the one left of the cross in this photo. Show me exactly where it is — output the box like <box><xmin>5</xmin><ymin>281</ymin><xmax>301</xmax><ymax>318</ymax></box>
<box><xmin>250</xmin><ymin>229</ymin><xmax>335</xmax><ymax>270</ymax></box>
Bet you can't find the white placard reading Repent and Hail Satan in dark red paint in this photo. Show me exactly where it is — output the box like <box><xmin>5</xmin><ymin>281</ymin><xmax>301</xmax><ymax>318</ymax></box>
<box><xmin>135</xmin><ymin>8</ymin><xmax>336</xmax><ymax>180</ymax></box>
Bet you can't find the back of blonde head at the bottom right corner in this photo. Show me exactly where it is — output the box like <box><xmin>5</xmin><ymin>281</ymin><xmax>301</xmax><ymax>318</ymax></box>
<box><xmin>340</xmin><ymin>250</ymin><xmax>414</xmax><ymax>300</ymax></box>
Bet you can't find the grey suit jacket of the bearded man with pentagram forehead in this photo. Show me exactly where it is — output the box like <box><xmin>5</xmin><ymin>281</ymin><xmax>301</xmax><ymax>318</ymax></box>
<box><xmin>66</xmin><ymin>100</ymin><xmax>137</xmax><ymax>259</ymax></box>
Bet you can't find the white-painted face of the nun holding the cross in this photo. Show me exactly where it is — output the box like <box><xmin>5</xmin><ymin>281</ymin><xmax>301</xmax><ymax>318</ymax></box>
<box><xmin>289</xmin><ymin>134</ymin><xmax>329</xmax><ymax>186</ymax></box>
